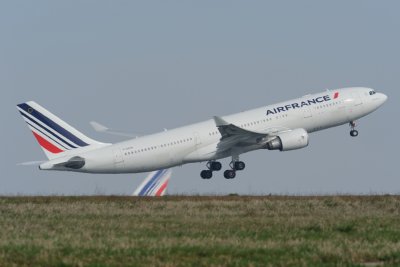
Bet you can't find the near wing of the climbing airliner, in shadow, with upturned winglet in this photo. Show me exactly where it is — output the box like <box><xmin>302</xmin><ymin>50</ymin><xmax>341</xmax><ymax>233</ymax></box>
<box><xmin>214</xmin><ymin>116</ymin><xmax>290</xmax><ymax>152</ymax></box>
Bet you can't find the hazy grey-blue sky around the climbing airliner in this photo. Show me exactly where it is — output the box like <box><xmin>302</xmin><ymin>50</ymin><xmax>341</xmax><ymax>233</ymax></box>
<box><xmin>0</xmin><ymin>0</ymin><xmax>400</xmax><ymax>194</ymax></box>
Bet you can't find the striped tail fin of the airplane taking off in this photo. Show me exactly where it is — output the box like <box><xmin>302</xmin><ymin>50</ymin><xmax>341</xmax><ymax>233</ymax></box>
<box><xmin>17</xmin><ymin>101</ymin><xmax>102</xmax><ymax>160</ymax></box>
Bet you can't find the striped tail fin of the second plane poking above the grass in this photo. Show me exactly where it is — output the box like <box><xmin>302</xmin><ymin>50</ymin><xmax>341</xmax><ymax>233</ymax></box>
<box><xmin>132</xmin><ymin>169</ymin><xmax>172</xmax><ymax>197</ymax></box>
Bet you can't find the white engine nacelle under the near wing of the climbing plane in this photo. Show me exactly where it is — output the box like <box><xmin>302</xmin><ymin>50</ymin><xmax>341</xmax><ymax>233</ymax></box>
<box><xmin>266</xmin><ymin>129</ymin><xmax>308</xmax><ymax>151</ymax></box>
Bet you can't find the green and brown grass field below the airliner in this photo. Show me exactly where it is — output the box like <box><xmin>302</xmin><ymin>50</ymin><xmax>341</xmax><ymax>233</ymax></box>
<box><xmin>0</xmin><ymin>196</ymin><xmax>400</xmax><ymax>266</ymax></box>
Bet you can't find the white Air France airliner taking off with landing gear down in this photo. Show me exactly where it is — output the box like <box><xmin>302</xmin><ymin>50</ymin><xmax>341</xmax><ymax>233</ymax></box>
<box><xmin>17</xmin><ymin>87</ymin><xmax>387</xmax><ymax>179</ymax></box>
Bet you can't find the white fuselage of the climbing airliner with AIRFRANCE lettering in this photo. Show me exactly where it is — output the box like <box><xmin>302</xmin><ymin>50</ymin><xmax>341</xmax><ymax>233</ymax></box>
<box><xmin>41</xmin><ymin>87</ymin><xmax>387</xmax><ymax>173</ymax></box>
